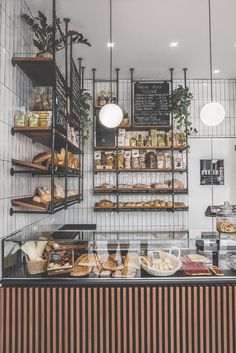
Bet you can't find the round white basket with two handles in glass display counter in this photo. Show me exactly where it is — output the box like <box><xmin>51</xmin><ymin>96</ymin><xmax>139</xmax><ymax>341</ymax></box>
<box><xmin>139</xmin><ymin>247</ymin><xmax>181</xmax><ymax>277</ymax></box>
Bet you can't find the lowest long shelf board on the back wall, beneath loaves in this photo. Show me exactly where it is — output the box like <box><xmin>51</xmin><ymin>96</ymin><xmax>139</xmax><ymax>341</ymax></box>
<box><xmin>94</xmin><ymin>207</ymin><xmax>188</xmax><ymax>212</ymax></box>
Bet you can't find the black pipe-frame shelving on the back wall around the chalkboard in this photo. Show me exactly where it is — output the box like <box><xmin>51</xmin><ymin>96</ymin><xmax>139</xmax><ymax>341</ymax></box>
<box><xmin>92</xmin><ymin>68</ymin><xmax>189</xmax><ymax>212</ymax></box>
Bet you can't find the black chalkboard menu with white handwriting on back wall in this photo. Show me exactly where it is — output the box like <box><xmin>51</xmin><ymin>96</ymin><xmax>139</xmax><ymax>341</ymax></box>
<box><xmin>133</xmin><ymin>81</ymin><xmax>170</xmax><ymax>126</ymax></box>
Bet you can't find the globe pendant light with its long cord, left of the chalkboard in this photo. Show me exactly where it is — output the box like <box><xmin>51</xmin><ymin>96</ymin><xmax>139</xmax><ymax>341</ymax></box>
<box><xmin>99</xmin><ymin>0</ymin><xmax>123</xmax><ymax>129</ymax></box>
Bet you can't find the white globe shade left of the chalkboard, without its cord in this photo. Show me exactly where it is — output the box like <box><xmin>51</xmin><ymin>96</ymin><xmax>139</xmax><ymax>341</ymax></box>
<box><xmin>99</xmin><ymin>103</ymin><xmax>123</xmax><ymax>129</ymax></box>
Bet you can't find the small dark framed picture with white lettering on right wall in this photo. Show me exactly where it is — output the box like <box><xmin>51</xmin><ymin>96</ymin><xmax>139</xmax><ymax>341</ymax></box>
<box><xmin>200</xmin><ymin>159</ymin><xmax>225</xmax><ymax>185</ymax></box>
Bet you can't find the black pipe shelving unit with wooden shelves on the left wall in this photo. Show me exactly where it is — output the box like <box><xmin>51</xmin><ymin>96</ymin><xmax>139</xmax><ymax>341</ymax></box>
<box><xmin>10</xmin><ymin>0</ymin><xmax>83</xmax><ymax>215</ymax></box>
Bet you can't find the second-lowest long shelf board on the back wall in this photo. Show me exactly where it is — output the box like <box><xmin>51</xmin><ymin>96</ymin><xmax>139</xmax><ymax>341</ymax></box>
<box><xmin>94</xmin><ymin>188</ymin><xmax>188</xmax><ymax>195</ymax></box>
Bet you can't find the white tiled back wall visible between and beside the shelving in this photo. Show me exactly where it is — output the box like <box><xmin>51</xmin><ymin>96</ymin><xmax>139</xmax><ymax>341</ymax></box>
<box><xmin>65</xmin><ymin>80</ymin><xmax>236</xmax><ymax>231</ymax></box>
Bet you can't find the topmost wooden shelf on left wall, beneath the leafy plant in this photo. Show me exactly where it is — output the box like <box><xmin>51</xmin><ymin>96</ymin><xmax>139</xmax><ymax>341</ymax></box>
<box><xmin>12</xmin><ymin>56</ymin><xmax>55</xmax><ymax>86</ymax></box>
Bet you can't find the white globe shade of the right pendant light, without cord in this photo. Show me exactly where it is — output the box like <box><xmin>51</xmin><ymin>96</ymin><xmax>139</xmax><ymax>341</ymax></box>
<box><xmin>200</xmin><ymin>102</ymin><xmax>225</xmax><ymax>126</ymax></box>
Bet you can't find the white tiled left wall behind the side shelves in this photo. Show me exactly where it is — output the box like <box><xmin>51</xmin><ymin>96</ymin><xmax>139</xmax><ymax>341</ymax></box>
<box><xmin>0</xmin><ymin>0</ymin><xmax>62</xmax><ymax>250</ymax></box>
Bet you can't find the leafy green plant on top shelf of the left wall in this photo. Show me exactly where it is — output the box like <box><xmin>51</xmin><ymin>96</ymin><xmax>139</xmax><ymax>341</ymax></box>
<box><xmin>22</xmin><ymin>11</ymin><xmax>91</xmax><ymax>58</ymax></box>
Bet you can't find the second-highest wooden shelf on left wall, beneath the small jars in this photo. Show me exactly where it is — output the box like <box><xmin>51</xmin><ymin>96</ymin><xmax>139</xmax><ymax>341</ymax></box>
<box><xmin>11</xmin><ymin>127</ymin><xmax>81</xmax><ymax>154</ymax></box>
